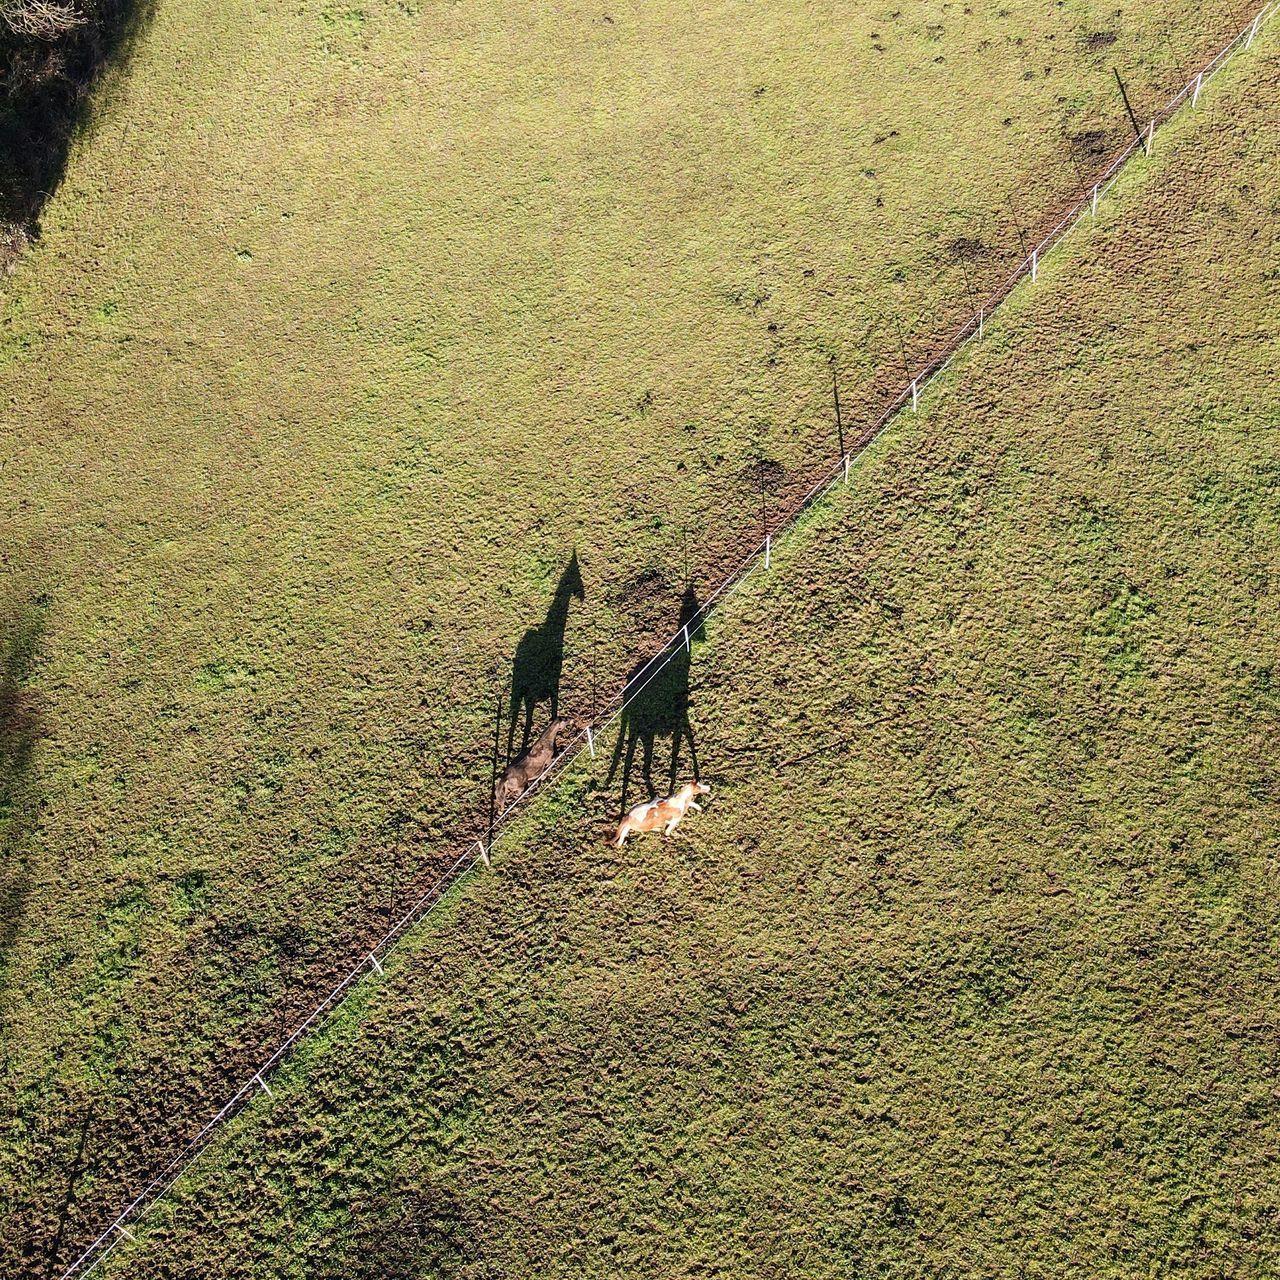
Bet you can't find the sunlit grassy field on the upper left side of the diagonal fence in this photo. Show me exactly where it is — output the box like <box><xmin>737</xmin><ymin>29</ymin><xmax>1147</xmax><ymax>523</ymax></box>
<box><xmin>0</xmin><ymin>0</ymin><xmax>1261</xmax><ymax>1274</ymax></box>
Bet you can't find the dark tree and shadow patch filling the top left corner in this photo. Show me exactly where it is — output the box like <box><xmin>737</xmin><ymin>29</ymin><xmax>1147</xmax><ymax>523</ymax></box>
<box><xmin>0</xmin><ymin>0</ymin><xmax>154</xmax><ymax>241</ymax></box>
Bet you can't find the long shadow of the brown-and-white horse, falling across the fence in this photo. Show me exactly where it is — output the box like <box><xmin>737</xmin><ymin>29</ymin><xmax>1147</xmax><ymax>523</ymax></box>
<box><xmin>604</xmin><ymin>585</ymin><xmax>704</xmax><ymax>813</ymax></box>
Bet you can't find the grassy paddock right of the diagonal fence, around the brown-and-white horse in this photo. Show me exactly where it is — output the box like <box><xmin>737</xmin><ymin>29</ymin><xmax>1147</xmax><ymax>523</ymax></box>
<box><xmin>90</xmin><ymin>30</ymin><xmax>1280</xmax><ymax>1280</ymax></box>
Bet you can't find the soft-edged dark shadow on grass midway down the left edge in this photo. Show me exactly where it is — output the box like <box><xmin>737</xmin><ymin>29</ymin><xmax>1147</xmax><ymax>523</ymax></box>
<box><xmin>0</xmin><ymin>598</ymin><xmax>46</xmax><ymax>1024</ymax></box>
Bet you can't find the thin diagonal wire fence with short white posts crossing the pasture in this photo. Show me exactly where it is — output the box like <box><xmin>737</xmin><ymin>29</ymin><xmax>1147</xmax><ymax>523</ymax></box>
<box><xmin>61</xmin><ymin>0</ymin><xmax>1280</xmax><ymax>1280</ymax></box>
